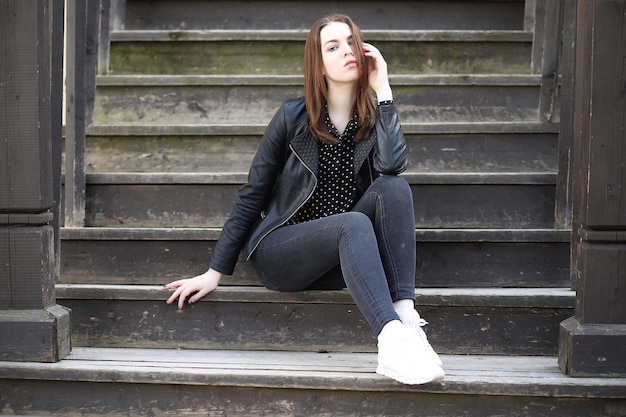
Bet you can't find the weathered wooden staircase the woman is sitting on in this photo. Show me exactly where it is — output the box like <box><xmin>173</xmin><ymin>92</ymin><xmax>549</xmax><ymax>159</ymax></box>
<box><xmin>0</xmin><ymin>0</ymin><xmax>626</xmax><ymax>417</ymax></box>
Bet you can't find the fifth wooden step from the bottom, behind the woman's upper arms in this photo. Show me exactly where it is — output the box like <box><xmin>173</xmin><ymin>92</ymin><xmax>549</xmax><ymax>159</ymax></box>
<box><xmin>85</xmin><ymin>123</ymin><xmax>558</xmax><ymax>173</ymax></box>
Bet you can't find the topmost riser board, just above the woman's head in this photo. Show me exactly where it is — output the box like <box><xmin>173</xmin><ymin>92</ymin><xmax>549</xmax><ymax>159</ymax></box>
<box><xmin>124</xmin><ymin>0</ymin><xmax>525</xmax><ymax>30</ymax></box>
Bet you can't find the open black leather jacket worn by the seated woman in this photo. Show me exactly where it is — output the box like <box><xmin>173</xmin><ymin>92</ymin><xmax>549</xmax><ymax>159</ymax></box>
<box><xmin>210</xmin><ymin>98</ymin><xmax>407</xmax><ymax>275</ymax></box>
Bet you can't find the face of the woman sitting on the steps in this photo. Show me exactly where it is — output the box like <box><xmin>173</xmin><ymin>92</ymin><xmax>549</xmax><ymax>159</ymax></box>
<box><xmin>320</xmin><ymin>22</ymin><xmax>359</xmax><ymax>83</ymax></box>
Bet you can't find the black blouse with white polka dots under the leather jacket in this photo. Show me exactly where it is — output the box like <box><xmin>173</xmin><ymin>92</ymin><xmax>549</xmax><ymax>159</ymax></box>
<box><xmin>289</xmin><ymin>108</ymin><xmax>359</xmax><ymax>224</ymax></box>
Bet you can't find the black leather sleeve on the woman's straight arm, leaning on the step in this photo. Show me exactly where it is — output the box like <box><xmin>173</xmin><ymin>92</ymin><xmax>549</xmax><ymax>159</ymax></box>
<box><xmin>210</xmin><ymin>104</ymin><xmax>288</xmax><ymax>275</ymax></box>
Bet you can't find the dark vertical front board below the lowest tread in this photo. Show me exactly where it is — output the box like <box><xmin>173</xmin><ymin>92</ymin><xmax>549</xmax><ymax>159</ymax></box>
<box><xmin>0</xmin><ymin>378</ymin><xmax>624</xmax><ymax>417</ymax></box>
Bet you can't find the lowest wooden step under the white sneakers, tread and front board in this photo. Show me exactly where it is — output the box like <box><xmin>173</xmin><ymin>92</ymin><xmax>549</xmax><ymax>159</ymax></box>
<box><xmin>0</xmin><ymin>348</ymin><xmax>626</xmax><ymax>417</ymax></box>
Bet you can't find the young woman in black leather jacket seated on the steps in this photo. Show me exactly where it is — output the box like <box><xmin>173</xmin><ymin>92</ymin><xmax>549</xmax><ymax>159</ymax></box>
<box><xmin>165</xmin><ymin>15</ymin><xmax>444</xmax><ymax>384</ymax></box>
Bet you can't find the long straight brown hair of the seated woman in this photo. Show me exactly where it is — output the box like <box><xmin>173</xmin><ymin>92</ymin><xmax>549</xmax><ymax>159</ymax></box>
<box><xmin>304</xmin><ymin>14</ymin><xmax>376</xmax><ymax>143</ymax></box>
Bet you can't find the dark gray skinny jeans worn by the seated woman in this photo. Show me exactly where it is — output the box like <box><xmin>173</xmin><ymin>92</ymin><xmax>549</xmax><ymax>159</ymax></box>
<box><xmin>251</xmin><ymin>176</ymin><xmax>416</xmax><ymax>335</ymax></box>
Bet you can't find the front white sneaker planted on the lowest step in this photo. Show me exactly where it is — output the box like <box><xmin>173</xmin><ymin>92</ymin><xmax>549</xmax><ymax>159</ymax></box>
<box><xmin>376</xmin><ymin>324</ymin><xmax>445</xmax><ymax>384</ymax></box>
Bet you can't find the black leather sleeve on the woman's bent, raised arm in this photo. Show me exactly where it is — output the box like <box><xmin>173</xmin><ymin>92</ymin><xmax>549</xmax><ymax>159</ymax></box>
<box><xmin>374</xmin><ymin>104</ymin><xmax>408</xmax><ymax>175</ymax></box>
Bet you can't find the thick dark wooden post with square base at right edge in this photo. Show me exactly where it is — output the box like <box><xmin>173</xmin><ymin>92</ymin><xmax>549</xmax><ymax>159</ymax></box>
<box><xmin>559</xmin><ymin>0</ymin><xmax>626</xmax><ymax>376</ymax></box>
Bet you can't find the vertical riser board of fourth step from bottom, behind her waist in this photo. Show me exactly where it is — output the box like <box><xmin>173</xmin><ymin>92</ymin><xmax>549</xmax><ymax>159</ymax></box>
<box><xmin>74</xmin><ymin>182</ymin><xmax>555</xmax><ymax>229</ymax></box>
